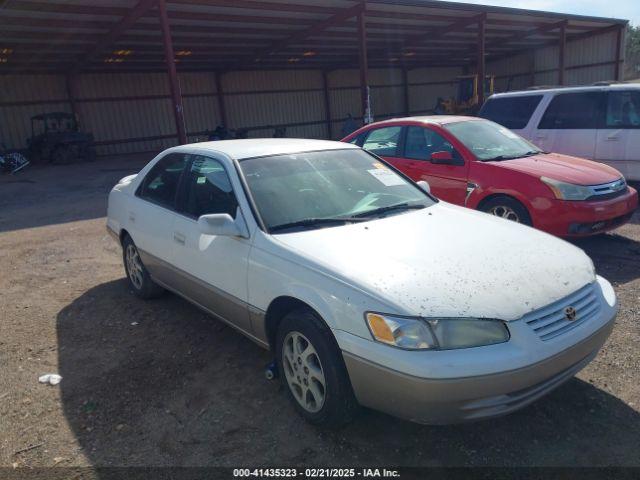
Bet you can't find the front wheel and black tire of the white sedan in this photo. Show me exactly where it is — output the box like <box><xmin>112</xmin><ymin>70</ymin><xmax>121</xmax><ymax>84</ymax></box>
<box><xmin>276</xmin><ymin>309</ymin><xmax>358</xmax><ymax>428</ymax></box>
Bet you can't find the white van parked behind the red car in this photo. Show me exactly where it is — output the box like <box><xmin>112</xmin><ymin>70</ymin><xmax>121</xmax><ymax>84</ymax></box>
<box><xmin>479</xmin><ymin>84</ymin><xmax>640</xmax><ymax>180</ymax></box>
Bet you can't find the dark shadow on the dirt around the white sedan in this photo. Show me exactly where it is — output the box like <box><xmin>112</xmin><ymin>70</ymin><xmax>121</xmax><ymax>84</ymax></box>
<box><xmin>57</xmin><ymin>279</ymin><xmax>640</xmax><ymax>466</ymax></box>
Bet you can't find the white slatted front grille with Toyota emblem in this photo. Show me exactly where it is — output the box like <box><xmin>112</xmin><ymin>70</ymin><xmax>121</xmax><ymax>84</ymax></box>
<box><xmin>523</xmin><ymin>283</ymin><xmax>600</xmax><ymax>341</ymax></box>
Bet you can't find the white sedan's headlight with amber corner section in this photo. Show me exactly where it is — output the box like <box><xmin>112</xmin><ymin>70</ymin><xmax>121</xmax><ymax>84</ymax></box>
<box><xmin>366</xmin><ymin>313</ymin><xmax>509</xmax><ymax>350</ymax></box>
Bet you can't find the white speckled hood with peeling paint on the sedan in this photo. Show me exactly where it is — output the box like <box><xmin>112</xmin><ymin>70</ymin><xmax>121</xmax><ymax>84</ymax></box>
<box><xmin>272</xmin><ymin>202</ymin><xmax>595</xmax><ymax>321</ymax></box>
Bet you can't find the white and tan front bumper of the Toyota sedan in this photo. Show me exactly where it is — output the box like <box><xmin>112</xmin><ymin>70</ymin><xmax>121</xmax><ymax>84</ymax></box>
<box><xmin>339</xmin><ymin>279</ymin><xmax>617</xmax><ymax>424</ymax></box>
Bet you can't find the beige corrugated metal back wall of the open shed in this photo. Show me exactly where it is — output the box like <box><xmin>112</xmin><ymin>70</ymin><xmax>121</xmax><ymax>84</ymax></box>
<box><xmin>0</xmin><ymin>28</ymin><xmax>616</xmax><ymax>155</ymax></box>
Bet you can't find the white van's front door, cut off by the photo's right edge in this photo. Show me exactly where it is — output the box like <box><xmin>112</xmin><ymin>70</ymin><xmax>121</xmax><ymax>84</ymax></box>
<box><xmin>596</xmin><ymin>90</ymin><xmax>640</xmax><ymax>180</ymax></box>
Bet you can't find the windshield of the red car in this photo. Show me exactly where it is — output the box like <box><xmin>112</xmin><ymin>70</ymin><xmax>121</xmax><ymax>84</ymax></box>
<box><xmin>444</xmin><ymin>120</ymin><xmax>542</xmax><ymax>161</ymax></box>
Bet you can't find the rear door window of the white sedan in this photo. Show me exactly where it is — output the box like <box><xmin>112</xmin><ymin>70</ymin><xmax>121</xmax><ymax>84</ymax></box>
<box><xmin>138</xmin><ymin>153</ymin><xmax>187</xmax><ymax>210</ymax></box>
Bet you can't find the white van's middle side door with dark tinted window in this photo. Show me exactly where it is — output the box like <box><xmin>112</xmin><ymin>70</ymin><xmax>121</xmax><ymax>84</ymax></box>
<box><xmin>531</xmin><ymin>90</ymin><xmax>606</xmax><ymax>159</ymax></box>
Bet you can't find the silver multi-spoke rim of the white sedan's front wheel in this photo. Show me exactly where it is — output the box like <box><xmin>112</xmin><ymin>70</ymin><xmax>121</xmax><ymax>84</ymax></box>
<box><xmin>282</xmin><ymin>332</ymin><xmax>326</xmax><ymax>413</ymax></box>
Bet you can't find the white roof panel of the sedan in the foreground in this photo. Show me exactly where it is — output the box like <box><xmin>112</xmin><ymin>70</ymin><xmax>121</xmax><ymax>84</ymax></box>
<box><xmin>185</xmin><ymin>138</ymin><xmax>359</xmax><ymax>160</ymax></box>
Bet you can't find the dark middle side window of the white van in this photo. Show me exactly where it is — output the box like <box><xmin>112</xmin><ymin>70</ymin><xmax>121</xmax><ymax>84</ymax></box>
<box><xmin>538</xmin><ymin>92</ymin><xmax>605</xmax><ymax>129</ymax></box>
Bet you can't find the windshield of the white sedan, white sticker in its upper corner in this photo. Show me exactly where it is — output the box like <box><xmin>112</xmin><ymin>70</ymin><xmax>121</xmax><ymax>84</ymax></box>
<box><xmin>240</xmin><ymin>149</ymin><xmax>434</xmax><ymax>232</ymax></box>
